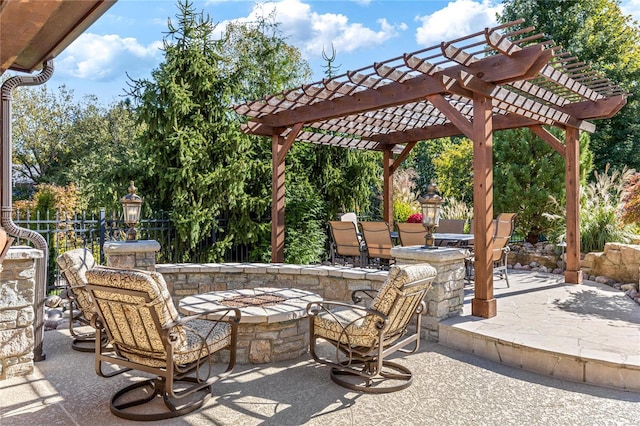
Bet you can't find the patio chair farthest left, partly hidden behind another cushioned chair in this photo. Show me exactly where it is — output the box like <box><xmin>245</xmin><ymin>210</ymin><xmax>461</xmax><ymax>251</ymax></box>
<box><xmin>56</xmin><ymin>248</ymin><xmax>106</xmax><ymax>352</ymax></box>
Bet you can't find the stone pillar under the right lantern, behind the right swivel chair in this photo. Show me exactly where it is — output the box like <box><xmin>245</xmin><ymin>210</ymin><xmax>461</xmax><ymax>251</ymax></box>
<box><xmin>391</xmin><ymin>246</ymin><xmax>468</xmax><ymax>342</ymax></box>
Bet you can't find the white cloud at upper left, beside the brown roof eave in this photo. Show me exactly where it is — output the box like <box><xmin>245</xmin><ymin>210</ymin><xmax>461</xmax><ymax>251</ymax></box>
<box><xmin>56</xmin><ymin>33</ymin><xmax>162</xmax><ymax>81</ymax></box>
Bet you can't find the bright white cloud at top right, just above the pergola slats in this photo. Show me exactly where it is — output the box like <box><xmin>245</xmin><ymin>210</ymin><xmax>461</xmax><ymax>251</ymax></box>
<box><xmin>416</xmin><ymin>0</ymin><xmax>502</xmax><ymax>47</ymax></box>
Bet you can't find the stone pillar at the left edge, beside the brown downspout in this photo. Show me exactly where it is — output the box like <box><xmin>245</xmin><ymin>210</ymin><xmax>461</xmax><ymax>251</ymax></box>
<box><xmin>0</xmin><ymin>246</ymin><xmax>44</xmax><ymax>380</ymax></box>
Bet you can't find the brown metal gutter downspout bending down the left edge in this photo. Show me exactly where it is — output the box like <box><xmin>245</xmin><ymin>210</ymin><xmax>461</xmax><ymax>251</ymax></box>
<box><xmin>0</xmin><ymin>59</ymin><xmax>53</xmax><ymax>361</ymax></box>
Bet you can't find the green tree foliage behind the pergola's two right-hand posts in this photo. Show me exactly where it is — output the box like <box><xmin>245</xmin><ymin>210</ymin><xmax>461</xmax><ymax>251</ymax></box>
<box><xmin>493</xmin><ymin>129</ymin><xmax>592</xmax><ymax>244</ymax></box>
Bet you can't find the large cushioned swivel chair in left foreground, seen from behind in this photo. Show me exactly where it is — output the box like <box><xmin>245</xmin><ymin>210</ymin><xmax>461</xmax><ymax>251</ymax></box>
<box><xmin>86</xmin><ymin>266</ymin><xmax>240</xmax><ymax>420</ymax></box>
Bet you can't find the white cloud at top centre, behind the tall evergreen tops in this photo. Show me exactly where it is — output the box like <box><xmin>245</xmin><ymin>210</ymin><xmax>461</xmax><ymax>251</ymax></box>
<box><xmin>218</xmin><ymin>0</ymin><xmax>407</xmax><ymax>57</ymax></box>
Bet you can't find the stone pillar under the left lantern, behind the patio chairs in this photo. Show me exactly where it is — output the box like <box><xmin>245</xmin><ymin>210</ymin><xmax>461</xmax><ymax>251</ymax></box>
<box><xmin>104</xmin><ymin>240</ymin><xmax>160</xmax><ymax>271</ymax></box>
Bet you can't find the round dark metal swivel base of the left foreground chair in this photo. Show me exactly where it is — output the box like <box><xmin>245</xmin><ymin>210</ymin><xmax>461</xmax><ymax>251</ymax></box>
<box><xmin>110</xmin><ymin>377</ymin><xmax>211</xmax><ymax>421</ymax></box>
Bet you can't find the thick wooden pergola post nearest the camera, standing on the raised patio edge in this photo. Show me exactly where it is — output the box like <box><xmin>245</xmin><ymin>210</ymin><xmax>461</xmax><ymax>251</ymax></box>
<box><xmin>471</xmin><ymin>93</ymin><xmax>497</xmax><ymax>318</ymax></box>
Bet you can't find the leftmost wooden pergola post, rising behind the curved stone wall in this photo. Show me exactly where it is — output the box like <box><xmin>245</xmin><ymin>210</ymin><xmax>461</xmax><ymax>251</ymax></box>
<box><xmin>271</xmin><ymin>135</ymin><xmax>286</xmax><ymax>263</ymax></box>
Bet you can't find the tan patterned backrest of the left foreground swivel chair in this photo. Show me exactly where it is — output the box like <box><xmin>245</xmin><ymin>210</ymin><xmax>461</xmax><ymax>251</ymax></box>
<box><xmin>86</xmin><ymin>266</ymin><xmax>186</xmax><ymax>367</ymax></box>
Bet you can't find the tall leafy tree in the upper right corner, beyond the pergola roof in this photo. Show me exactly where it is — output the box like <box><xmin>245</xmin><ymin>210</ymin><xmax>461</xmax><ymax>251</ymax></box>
<box><xmin>501</xmin><ymin>0</ymin><xmax>640</xmax><ymax>171</ymax></box>
